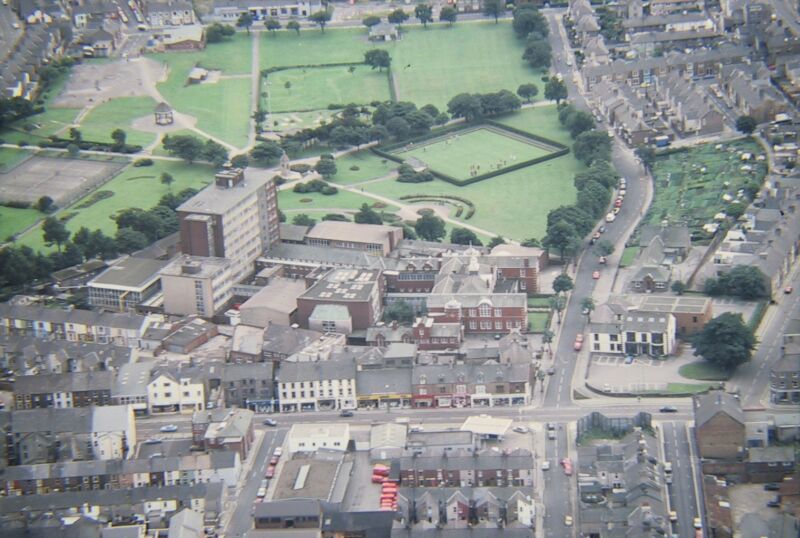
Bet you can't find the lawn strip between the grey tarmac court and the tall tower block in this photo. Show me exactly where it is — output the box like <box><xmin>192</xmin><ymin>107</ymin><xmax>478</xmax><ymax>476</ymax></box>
<box><xmin>19</xmin><ymin>161</ymin><xmax>213</xmax><ymax>251</ymax></box>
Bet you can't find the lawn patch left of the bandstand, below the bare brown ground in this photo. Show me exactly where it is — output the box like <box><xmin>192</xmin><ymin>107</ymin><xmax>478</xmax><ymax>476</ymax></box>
<box><xmin>80</xmin><ymin>97</ymin><xmax>158</xmax><ymax>146</ymax></box>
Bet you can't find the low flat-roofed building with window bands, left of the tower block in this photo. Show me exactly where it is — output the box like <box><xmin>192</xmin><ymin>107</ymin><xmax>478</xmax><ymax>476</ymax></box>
<box><xmin>88</xmin><ymin>257</ymin><xmax>169</xmax><ymax>312</ymax></box>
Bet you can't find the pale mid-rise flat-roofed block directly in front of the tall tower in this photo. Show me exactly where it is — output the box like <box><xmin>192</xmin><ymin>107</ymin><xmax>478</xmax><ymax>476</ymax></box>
<box><xmin>161</xmin><ymin>255</ymin><xmax>235</xmax><ymax>318</ymax></box>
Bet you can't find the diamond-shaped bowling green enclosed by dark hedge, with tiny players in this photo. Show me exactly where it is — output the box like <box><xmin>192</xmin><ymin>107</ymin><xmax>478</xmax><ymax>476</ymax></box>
<box><xmin>392</xmin><ymin>127</ymin><xmax>552</xmax><ymax>180</ymax></box>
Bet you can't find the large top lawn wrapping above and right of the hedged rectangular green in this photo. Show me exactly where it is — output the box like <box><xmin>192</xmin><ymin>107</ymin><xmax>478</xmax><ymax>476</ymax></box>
<box><xmin>260</xmin><ymin>21</ymin><xmax>543</xmax><ymax>109</ymax></box>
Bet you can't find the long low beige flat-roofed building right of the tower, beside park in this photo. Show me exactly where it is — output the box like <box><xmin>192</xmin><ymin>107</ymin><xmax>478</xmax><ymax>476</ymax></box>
<box><xmin>306</xmin><ymin>220</ymin><xmax>403</xmax><ymax>256</ymax></box>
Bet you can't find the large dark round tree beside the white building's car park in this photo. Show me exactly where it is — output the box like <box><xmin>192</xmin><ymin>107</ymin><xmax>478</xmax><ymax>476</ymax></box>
<box><xmin>692</xmin><ymin>312</ymin><xmax>756</xmax><ymax>372</ymax></box>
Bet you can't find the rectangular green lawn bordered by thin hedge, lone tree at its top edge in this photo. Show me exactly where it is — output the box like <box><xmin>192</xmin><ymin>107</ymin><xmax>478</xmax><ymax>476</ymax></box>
<box><xmin>261</xmin><ymin>65</ymin><xmax>390</xmax><ymax>112</ymax></box>
